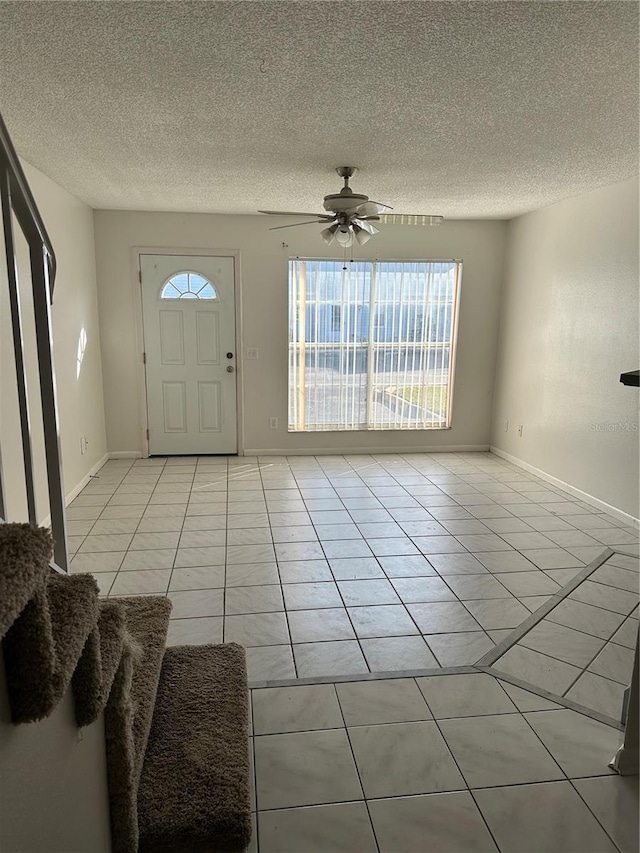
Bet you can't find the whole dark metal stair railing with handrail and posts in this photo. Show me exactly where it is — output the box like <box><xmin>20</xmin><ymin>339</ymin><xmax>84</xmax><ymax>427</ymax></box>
<box><xmin>0</xmin><ymin>111</ymin><xmax>68</xmax><ymax>572</ymax></box>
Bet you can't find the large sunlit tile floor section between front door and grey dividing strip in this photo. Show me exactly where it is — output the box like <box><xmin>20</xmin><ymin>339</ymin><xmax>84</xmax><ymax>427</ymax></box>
<box><xmin>68</xmin><ymin>453</ymin><xmax>638</xmax><ymax>682</ymax></box>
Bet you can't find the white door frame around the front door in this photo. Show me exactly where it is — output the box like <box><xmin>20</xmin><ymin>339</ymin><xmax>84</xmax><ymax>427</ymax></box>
<box><xmin>130</xmin><ymin>246</ymin><xmax>244</xmax><ymax>459</ymax></box>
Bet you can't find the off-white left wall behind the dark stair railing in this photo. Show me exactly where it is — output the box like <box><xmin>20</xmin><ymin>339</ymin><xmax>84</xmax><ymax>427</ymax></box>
<box><xmin>0</xmin><ymin>163</ymin><xmax>106</xmax><ymax>520</ymax></box>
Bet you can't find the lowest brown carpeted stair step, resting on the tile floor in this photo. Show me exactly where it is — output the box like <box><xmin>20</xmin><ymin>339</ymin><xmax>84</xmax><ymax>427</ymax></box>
<box><xmin>138</xmin><ymin>643</ymin><xmax>251</xmax><ymax>853</ymax></box>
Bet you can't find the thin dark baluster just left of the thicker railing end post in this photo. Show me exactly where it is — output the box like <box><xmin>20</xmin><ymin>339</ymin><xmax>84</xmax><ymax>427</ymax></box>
<box><xmin>0</xmin><ymin>171</ymin><xmax>38</xmax><ymax>524</ymax></box>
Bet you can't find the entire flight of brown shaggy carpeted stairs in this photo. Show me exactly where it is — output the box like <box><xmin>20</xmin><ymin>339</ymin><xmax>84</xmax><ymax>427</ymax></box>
<box><xmin>0</xmin><ymin>524</ymin><xmax>251</xmax><ymax>853</ymax></box>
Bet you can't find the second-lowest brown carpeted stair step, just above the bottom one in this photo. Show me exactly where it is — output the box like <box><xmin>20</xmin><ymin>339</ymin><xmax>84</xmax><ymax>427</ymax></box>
<box><xmin>105</xmin><ymin>596</ymin><xmax>171</xmax><ymax>853</ymax></box>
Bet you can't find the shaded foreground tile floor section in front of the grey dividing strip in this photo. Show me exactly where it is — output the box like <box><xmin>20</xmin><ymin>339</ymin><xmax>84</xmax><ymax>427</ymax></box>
<box><xmin>244</xmin><ymin>674</ymin><xmax>638</xmax><ymax>853</ymax></box>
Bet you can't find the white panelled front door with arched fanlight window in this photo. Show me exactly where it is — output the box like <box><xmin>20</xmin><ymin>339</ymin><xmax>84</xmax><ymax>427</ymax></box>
<box><xmin>140</xmin><ymin>255</ymin><xmax>238</xmax><ymax>456</ymax></box>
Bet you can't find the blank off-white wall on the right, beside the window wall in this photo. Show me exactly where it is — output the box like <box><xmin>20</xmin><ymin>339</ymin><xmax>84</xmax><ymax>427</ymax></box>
<box><xmin>492</xmin><ymin>180</ymin><xmax>640</xmax><ymax>518</ymax></box>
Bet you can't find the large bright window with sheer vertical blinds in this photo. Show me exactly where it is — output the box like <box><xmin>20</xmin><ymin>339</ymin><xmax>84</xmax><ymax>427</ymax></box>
<box><xmin>289</xmin><ymin>259</ymin><xmax>462</xmax><ymax>432</ymax></box>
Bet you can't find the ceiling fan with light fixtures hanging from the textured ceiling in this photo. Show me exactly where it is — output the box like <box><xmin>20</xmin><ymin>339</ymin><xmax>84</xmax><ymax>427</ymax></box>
<box><xmin>258</xmin><ymin>166</ymin><xmax>444</xmax><ymax>248</ymax></box>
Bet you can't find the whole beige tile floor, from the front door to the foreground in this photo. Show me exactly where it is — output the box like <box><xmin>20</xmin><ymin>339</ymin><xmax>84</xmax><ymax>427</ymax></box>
<box><xmin>69</xmin><ymin>454</ymin><xmax>638</xmax><ymax>853</ymax></box>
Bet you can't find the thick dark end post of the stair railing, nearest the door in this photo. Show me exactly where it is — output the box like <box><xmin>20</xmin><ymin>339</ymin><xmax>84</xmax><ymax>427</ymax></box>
<box><xmin>30</xmin><ymin>246</ymin><xmax>68</xmax><ymax>571</ymax></box>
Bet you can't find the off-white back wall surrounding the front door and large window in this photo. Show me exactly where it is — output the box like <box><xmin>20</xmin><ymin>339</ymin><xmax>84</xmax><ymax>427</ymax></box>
<box><xmin>95</xmin><ymin>210</ymin><xmax>506</xmax><ymax>453</ymax></box>
